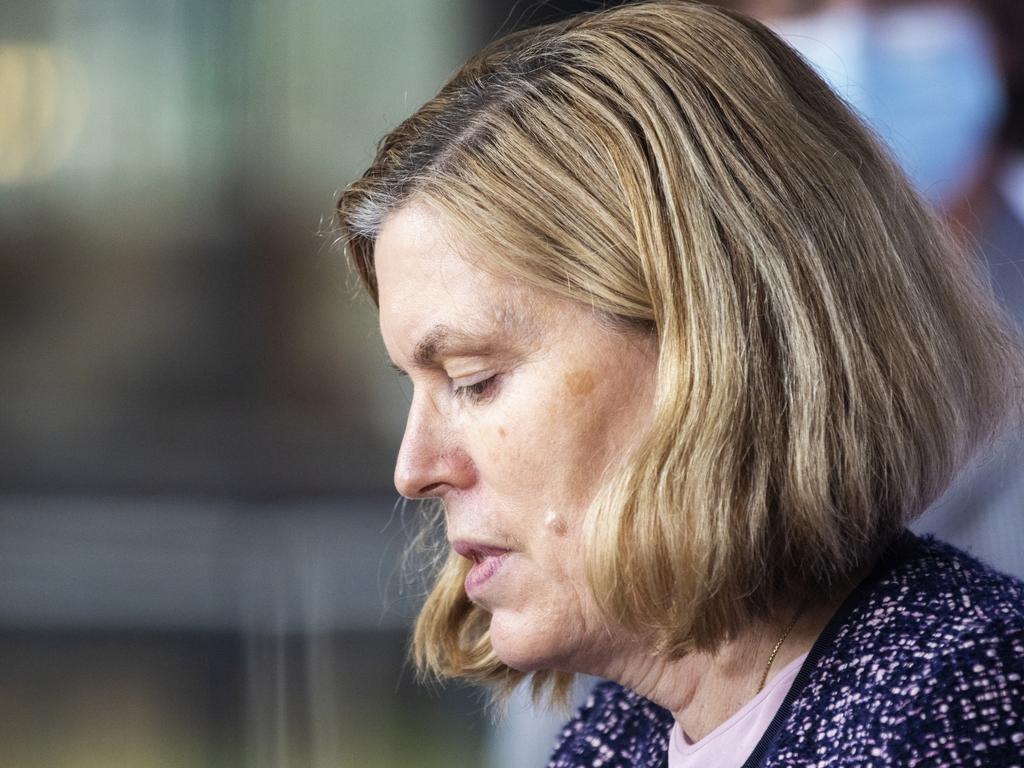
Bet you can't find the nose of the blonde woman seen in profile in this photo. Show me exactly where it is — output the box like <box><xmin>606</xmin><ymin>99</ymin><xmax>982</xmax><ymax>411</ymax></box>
<box><xmin>394</xmin><ymin>394</ymin><xmax>476</xmax><ymax>499</ymax></box>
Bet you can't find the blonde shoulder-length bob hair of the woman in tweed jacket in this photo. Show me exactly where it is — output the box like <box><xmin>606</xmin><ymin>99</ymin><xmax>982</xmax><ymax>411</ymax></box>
<box><xmin>338</xmin><ymin>2</ymin><xmax>1020</xmax><ymax>704</ymax></box>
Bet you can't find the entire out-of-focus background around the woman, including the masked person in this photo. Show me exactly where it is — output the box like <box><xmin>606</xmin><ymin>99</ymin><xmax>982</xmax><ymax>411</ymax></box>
<box><xmin>0</xmin><ymin>0</ymin><xmax>1024</xmax><ymax>768</ymax></box>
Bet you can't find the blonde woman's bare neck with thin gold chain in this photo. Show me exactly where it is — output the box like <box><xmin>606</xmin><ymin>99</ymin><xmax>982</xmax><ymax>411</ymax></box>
<box><xmin>601</xmin><ymin>598</ymin><xmax>842</xmax><ymax>741</ymax></box>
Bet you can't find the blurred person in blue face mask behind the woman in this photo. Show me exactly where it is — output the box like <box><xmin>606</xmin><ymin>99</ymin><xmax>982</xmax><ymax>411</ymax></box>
<box><xmin>729</xmin><ymin>0</ymin><xmax>1024</xmax><ymax>578</ymax></box>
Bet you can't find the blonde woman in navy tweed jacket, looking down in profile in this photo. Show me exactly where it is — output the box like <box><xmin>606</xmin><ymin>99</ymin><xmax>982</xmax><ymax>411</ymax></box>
<box><xmin>338</xmin><ymin>3</ymin><xmax>1024</xmax><ymax>767</ymax></box>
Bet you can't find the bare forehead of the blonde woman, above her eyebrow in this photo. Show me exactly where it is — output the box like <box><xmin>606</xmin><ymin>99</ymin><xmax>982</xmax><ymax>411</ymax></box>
<box><xmin>374</xmin><ymin>204</ymin><xmax>540</xmax><ymax>347</ymax></box>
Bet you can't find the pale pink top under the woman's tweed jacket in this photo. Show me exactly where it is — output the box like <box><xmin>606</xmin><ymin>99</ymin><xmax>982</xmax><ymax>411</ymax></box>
<box><xmin>669</xmin><ymin>653</ymin><xmax>807</xmax><ymax>768</ymax></box>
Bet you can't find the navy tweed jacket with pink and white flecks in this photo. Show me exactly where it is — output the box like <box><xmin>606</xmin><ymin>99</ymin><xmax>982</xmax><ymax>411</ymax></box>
<box><xmin>549</xmin><ymin>531</ymin><xmax>1024</xmax><ymax>768</ymax></box>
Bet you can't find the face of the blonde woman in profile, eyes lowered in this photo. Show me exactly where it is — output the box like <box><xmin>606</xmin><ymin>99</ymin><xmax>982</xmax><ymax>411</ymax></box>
<box><xmin>375</xmin><ymin>205</ymin><xmax>655</xmax><ymax>671</ymax></box>
